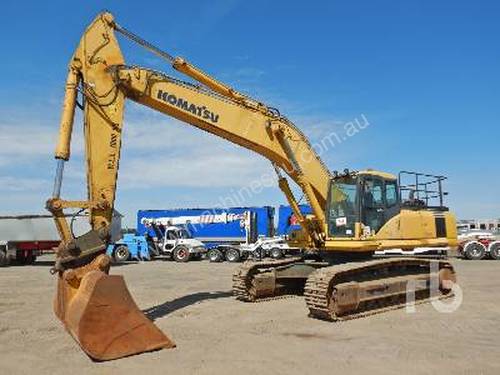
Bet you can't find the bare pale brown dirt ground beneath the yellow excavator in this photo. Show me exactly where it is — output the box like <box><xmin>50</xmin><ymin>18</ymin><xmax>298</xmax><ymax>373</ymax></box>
<box><xmin>0</xmin><ymin>258</ymin><xmax>500</xmax><ymax>375</ymax></box>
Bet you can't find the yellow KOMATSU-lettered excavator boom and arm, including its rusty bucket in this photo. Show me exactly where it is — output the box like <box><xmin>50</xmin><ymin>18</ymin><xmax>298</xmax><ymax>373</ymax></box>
<box><xmin>46</xmin><ymin>13</ymin><xmax>330</xmax><ymax>360</ymax></box>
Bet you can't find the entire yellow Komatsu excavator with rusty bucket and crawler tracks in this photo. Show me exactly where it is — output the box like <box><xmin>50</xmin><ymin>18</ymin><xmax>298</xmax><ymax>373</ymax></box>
<box><xmin>46</xmin><ymin>12</ymin><xmax>456</xmax><ymax>360</ymax></box>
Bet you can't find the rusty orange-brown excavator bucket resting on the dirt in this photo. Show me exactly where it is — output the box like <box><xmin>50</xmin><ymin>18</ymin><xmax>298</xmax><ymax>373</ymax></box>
<box><xmin>54</xmin><ymin>264</ymin><xmax>175</xmax><ymax>361</ymax></box>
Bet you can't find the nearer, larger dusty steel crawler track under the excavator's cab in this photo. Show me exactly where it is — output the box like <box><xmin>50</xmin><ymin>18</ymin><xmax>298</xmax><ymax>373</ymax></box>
<box><xmin>304</xmin><ymin>258</ymin><xmax>455</xmax><ymax>321</ymax></box>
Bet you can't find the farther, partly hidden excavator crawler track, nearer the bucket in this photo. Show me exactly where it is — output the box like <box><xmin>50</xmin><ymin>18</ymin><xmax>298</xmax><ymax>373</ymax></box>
<box><xmin>233</xmin><ymin>257</ymin><xmax>302</xmax><ymax>302</ymax></box>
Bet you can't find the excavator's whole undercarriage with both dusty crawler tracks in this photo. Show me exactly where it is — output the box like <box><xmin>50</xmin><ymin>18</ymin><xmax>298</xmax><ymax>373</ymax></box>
<box><xmin>233</xmin><ymin>254</ymin><xmax>456</xmax><ymax>321</ymax></box>
